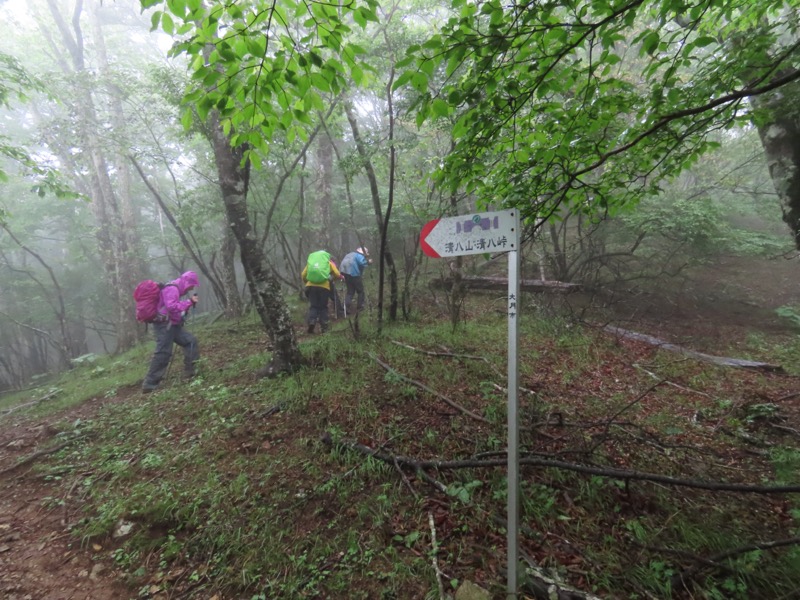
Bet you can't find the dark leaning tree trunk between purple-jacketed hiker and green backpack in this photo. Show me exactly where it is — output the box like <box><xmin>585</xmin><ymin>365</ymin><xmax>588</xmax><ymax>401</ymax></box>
<box><xmin>209</xmin><ymin>113</ymin><xmax>303</xmax><ymax>377</ymax></box>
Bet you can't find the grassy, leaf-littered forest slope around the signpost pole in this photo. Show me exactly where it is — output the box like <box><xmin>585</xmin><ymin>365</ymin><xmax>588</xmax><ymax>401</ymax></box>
<box><xmin>9</xmin><ymin>311</ymin><xmax>800</xmax><ymax>599</ymax></box>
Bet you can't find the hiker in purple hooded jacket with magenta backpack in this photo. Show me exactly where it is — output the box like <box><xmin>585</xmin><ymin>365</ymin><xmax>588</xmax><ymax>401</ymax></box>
<box><xmin>142</xmin><ymin>271</ymin><xmax>200</xmax><ymax>392</ymax></box>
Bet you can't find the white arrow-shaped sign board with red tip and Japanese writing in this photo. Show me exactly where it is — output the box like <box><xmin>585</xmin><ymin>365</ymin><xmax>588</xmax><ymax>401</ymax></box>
<box><xmin>419</xmin><ymin>210</ymin><xmax>518</xmax><ymax>258</ymax></box>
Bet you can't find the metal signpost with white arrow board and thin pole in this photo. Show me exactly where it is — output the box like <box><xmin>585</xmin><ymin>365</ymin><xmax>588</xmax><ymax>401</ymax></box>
<box><xmin>420</xmin><ymin>210</ymin><xmax>520</xmax><ymax>600</ymax></box>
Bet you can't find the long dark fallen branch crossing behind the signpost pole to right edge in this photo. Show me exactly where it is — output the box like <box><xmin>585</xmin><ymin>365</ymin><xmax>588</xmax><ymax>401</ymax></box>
<box><xmin>322</xmin><ymin>432</ymin><xmax>800</xmax><ymax>494</ymax></box>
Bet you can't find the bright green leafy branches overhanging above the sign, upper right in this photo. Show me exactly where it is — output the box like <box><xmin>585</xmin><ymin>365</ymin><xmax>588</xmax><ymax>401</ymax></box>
<box><xmin>394</xmin><ymin>0</ymin><xmax>800</xmax><ymax>232</ymax></box>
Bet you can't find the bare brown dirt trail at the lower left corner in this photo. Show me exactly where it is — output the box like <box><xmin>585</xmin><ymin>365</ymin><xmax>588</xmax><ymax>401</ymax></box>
<box><xmin>0</xmin><ymin>390</ymin><xmax>137</xmax><ymax>600</ymax></box>
